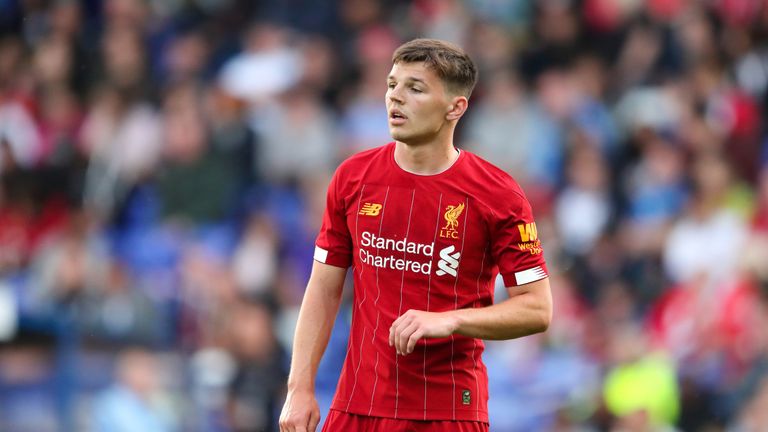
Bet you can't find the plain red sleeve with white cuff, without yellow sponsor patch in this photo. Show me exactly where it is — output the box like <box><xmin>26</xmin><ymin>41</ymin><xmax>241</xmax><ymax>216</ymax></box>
<box><xmin>314</xmin><ymin>169</ymin><xmax>352</xmax><ymax>268</ymax></box>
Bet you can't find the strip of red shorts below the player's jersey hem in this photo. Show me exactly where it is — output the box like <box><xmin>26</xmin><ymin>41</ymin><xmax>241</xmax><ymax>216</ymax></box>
<box><xmin>323</xmin><ymin>410</ymin><xmax>488</xmax><ymax>432</ymax></box>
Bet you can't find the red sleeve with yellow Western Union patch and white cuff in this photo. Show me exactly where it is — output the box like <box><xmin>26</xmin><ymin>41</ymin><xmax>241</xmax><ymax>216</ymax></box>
<box><xmin>490</xmin><ymin>191</ymin><xmax>549</xmax><ymax>287</ymax></box>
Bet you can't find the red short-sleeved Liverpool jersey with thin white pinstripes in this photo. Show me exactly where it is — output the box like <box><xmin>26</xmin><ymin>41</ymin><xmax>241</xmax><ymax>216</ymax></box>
<box><xmin>315</xmin><ymin>143</ymin><xmax>547</xmax><ymax>422</ymax></box>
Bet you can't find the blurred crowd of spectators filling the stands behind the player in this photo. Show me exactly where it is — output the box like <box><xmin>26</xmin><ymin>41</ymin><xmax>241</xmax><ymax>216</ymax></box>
<box><xmin>0</xmin><ymin>0</ymin><xmax>768</xmax><ymax>432</ymax></box>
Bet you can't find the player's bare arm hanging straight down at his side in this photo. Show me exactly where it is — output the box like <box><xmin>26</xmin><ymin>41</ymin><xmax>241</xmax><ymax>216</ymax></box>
<box><xmin>280</xmin><ymin>261</ymin><xmax>347</xmax><ymax>432</ymax></box>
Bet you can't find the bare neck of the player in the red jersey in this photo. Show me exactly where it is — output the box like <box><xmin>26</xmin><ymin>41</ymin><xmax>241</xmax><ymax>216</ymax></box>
<box><xmin>395</xmin><ymin>141</ymin><xmax>459</xmax><ymax>175</ymax></box>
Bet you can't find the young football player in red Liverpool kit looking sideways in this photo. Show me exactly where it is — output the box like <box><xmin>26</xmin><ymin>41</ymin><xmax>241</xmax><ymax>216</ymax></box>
<box><xmin>280</xmin><ymin>39</ymin><xmax>552</xmax><ymax>432</ymax></box>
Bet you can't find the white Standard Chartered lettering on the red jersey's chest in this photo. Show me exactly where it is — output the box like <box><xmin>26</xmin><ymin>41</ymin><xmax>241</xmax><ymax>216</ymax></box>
<box><xmin>359</xmin><ymin>231</ymin><xmax>435</xmax><ymax>274</ymax></box>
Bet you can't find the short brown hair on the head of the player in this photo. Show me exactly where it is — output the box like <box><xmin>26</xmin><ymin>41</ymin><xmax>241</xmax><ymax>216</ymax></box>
<box><xmin>392</xmin><ymin>39</ymin><xmax>477</xmax><ymax>97</ymax></box>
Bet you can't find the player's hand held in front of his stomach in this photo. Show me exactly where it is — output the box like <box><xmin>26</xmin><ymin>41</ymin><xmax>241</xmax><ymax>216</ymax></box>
<box><xmin>389</xmin><ymin>309</ymin><xmax>458</xmax><ymax>355</ymax></box>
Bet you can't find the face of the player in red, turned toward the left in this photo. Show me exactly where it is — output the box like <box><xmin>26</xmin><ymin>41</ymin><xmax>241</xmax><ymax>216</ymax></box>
<box><xmin>386</xmin><ymin>63</ymin><xmax>452</xmax><ymax>145</ymax></box>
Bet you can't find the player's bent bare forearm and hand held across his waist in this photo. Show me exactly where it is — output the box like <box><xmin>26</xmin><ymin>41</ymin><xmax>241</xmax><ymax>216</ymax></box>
<box><xmin>389</xmin><ymin>277</ymin><xmax>552</xmax><ymax>355</ymax></box>
